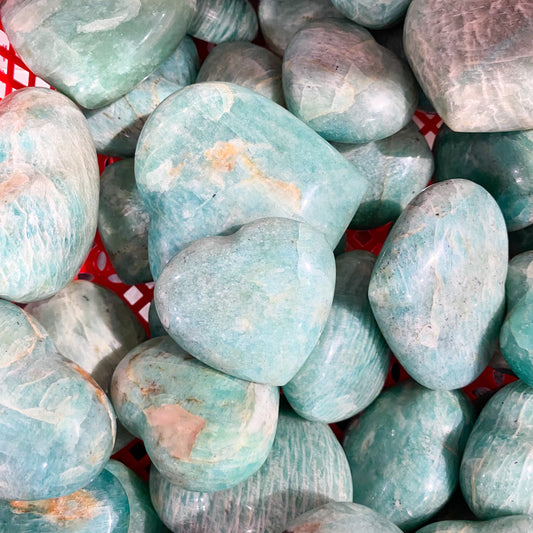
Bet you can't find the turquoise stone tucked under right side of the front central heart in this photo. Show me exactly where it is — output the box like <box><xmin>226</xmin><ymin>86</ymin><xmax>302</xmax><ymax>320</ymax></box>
<box><xmin>283</xmin><ymin>250</ymin><xmax>390</xmax><ymax>423</ymax></box>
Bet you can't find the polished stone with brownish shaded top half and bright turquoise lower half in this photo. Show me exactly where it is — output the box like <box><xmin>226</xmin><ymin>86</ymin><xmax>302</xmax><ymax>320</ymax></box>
<box><xmin>282</xmin><ymin>19</ymin><xmax>417</xmax><ymax>143</ymax></box>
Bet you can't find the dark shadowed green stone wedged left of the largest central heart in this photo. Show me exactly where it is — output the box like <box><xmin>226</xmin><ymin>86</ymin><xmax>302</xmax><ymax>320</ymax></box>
<box><xmin>98</xmin><ymin>159</ymin><xmax>152</xmax><ymax>285</ymax></box>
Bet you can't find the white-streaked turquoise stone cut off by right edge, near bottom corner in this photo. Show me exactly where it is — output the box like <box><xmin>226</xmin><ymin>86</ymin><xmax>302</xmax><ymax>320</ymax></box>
<box><xmin>460</xmin><ymin>380</ymin><xmax>533</xmax><ymax>520</ymax></box>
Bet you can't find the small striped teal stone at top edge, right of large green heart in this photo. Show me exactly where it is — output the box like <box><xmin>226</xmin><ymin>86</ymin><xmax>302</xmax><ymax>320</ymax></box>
<box><xmin>187</xmin><ymin>0</ymin><xmax>258</xmax><ymax>44</ymax></box>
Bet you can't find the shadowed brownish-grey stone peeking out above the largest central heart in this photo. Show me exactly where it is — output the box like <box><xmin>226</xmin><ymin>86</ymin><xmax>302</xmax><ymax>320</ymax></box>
<box><xmin>197</xmin><ymin>41</ymin><xmax>284</xmax><ymax>105</ymax></box>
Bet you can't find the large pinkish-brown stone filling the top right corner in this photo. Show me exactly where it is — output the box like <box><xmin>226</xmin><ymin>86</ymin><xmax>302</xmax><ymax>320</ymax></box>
<box><xmin>404</xmin><ymin>0</ymin><xmax>533</xmax><ymax>133</ymax></box>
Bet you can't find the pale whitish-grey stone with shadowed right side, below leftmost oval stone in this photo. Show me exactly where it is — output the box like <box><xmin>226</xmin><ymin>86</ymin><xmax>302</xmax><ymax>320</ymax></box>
<box><xmin>26</xmin><ymin>280</ymin><xmax>146</xmax><ymax>393</ymax></box>
